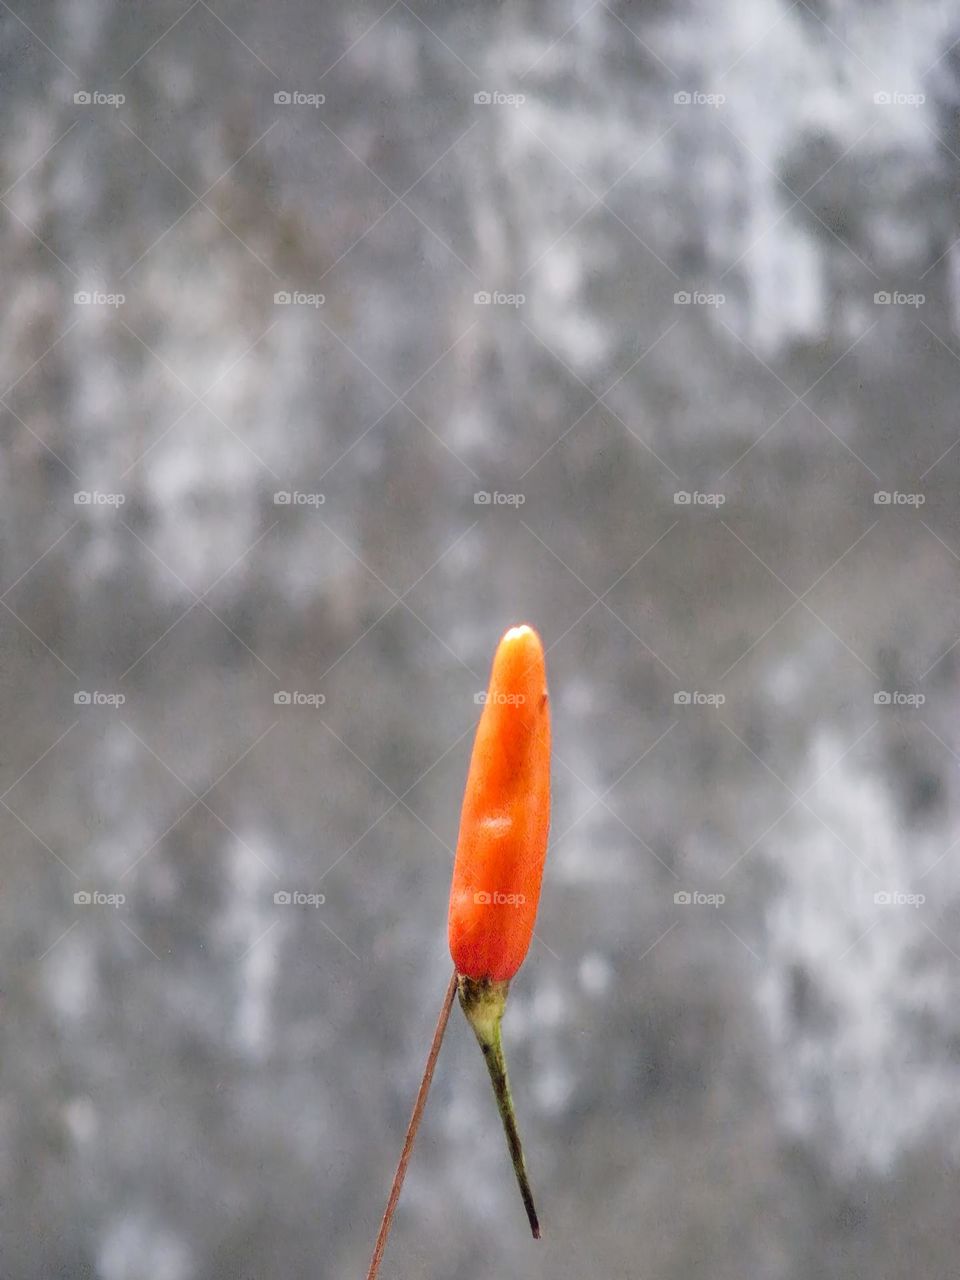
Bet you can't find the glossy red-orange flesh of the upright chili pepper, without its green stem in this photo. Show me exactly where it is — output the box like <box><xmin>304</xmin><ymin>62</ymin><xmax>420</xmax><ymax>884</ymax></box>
<box><xmin>448</xmin><ymin>626</ymin><xmax>550</xmax><ymax>982</ymax></box>
